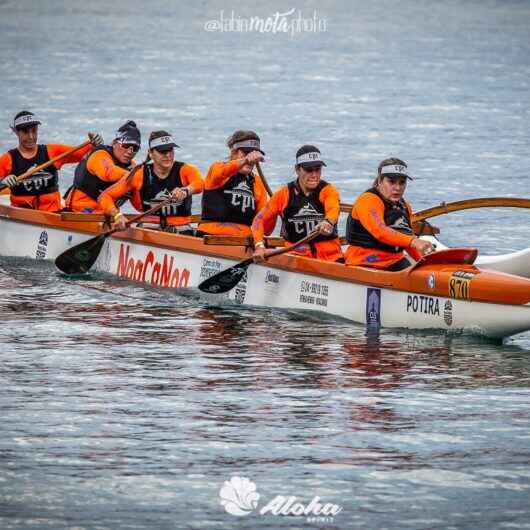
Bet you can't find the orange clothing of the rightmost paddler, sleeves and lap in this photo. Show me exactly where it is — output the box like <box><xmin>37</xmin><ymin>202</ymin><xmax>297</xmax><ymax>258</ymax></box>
<box><xmin>345</xmin><ymin>192</ymin><xmax>418</xmax><ymax>269</ymax></box>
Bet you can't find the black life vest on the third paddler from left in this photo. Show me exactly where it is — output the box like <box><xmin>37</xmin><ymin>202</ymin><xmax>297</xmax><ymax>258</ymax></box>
<box><xmin>140</xmin><ymin>162</ymin><xmax>191</xmax><ymax>220</ymax></box>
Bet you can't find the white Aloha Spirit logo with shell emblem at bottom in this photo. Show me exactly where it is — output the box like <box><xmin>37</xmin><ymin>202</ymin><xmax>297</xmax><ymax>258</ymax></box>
<box><xmin>219</xmin><ymin>476</ymin><xmax>342</xmax><ymax>523</ymax></box>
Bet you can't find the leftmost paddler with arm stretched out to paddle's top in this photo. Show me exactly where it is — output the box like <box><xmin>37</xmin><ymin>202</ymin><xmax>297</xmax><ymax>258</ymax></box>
<box><xmin>0</xmin><ymin>110</ymin><xmax>103</xmax><ymax>212</ymax></box>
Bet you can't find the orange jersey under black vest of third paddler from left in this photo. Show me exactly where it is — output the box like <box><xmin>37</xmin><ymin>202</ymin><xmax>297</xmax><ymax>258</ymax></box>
<box><xmin>98</xmin><ymin>164</ymin><xmax>204</xmax><ymax>225</ymax></box>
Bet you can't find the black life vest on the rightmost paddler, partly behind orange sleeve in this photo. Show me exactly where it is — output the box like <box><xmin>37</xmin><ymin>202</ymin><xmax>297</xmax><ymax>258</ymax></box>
<box><xmin>346</xmin><ymin>188</ymin><xmax>414</xmax><ymax>252</ymax></box>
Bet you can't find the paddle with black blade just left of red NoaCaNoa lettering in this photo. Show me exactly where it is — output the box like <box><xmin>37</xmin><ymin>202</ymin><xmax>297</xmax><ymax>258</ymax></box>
<box><xmin>55</xmin><ymin>164</ymin><xmax>173</xmax><ymax>274</ymax></box>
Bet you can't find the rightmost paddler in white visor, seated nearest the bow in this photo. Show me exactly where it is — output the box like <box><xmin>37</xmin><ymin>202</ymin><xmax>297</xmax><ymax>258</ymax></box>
<box><xmin>345</xmin><ymin>158</ymin><xmax>434</xmax><ymax>271</ymax></box>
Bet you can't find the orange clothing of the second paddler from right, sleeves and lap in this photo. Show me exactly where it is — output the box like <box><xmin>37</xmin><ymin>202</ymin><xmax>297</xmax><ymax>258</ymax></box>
<box><xmin>252</xmin><ymin>180</ymin><xmax>343</xmax><ymax>261</ymax></box>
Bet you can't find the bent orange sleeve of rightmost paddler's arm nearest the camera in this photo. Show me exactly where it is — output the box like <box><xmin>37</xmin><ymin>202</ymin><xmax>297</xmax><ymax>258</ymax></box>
<box><xmin>353</xmin><ymin>193</ymin><xmax>415</xmax><ymax>248</ymax></box>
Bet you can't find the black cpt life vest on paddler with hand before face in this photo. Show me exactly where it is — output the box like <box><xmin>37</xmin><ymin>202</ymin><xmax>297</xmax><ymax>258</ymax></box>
<box><xmin>201</xmin><ymin>173</ymin><xmax>256</xmax><ymax>226</ymax></box>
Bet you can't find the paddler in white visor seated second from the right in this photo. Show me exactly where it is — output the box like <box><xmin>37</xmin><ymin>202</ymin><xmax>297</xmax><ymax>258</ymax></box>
<box><xmin>252</xmin><ymin>145</ymin><xmax>344</xmax><ymax>263</ymax></box>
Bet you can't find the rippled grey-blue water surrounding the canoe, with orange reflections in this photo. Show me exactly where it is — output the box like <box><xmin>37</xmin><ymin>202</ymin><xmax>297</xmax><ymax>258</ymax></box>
<box><xmin>0</xmin><ymin>0</ymin><xmax>530</xmax><ymax>530</ymax></box>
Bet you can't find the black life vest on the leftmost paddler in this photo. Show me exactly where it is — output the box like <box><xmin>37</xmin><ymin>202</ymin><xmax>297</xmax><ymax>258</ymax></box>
<box><xmin>9</xmin><ymin>144</ymin><xmax>59</xmax><ymax>197</ymax></box>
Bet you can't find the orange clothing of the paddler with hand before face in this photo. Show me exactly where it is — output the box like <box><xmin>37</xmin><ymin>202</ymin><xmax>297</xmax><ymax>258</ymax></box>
<box><xmin>198</xmin><ymin>160</ymin><xmax>268</xmax><ymax>236</ymax></box>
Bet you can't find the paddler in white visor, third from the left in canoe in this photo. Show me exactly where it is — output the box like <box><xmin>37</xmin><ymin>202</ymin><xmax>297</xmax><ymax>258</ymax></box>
<box><xmin>98</xmin><ymin>131</ymin><xmax>204</xmax><ymax>235</ymax></box>
